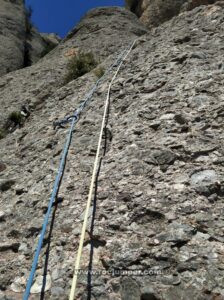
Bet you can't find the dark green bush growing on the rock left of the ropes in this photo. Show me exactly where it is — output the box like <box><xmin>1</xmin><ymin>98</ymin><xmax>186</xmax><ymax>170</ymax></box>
<box><xmin>64</xmin><ymin>53</ymin><xmax>98</xmax><ymax>84</ymax></box>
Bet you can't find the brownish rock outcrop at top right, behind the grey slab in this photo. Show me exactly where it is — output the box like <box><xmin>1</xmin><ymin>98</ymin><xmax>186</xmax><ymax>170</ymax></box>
<box><xmin>126</xmin><ymin>0</ymin><xmax>219</xmax><ymax>28</ymax></box>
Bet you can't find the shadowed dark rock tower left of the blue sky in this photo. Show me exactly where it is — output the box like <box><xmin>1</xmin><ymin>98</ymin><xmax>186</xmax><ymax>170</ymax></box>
<box><xmin>0</xmin><ymin>0</ymin><xmax>59</xmax><ymax>76</ymax></box>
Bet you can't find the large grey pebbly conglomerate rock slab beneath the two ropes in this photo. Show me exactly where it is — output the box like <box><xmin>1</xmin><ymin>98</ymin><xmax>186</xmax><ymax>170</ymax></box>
<box><xmin>0</xmin><ymin>3</ymin><xmax>224</xmax><ymax>300</ymax></box>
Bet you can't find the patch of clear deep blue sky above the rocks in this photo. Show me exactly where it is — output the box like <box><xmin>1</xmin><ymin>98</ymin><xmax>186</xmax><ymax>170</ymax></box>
<box><xmin>26</xmin><ymin>0</ymin><xmax>124</xmax><ymax>37</ymax></box>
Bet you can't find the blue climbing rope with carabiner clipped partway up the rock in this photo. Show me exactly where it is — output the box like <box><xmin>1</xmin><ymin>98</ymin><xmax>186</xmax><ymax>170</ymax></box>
<box><xmin>23</xmin><ymin>43</ymin><xmax>133</xmax><ymax>300</ymax></box>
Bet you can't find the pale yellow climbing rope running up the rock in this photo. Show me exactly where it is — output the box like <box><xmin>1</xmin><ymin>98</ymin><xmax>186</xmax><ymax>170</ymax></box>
<box><xmin>69</xmin><ymin>39</ymin><xmax>137</xmax><ymax>300</ymax></box>
